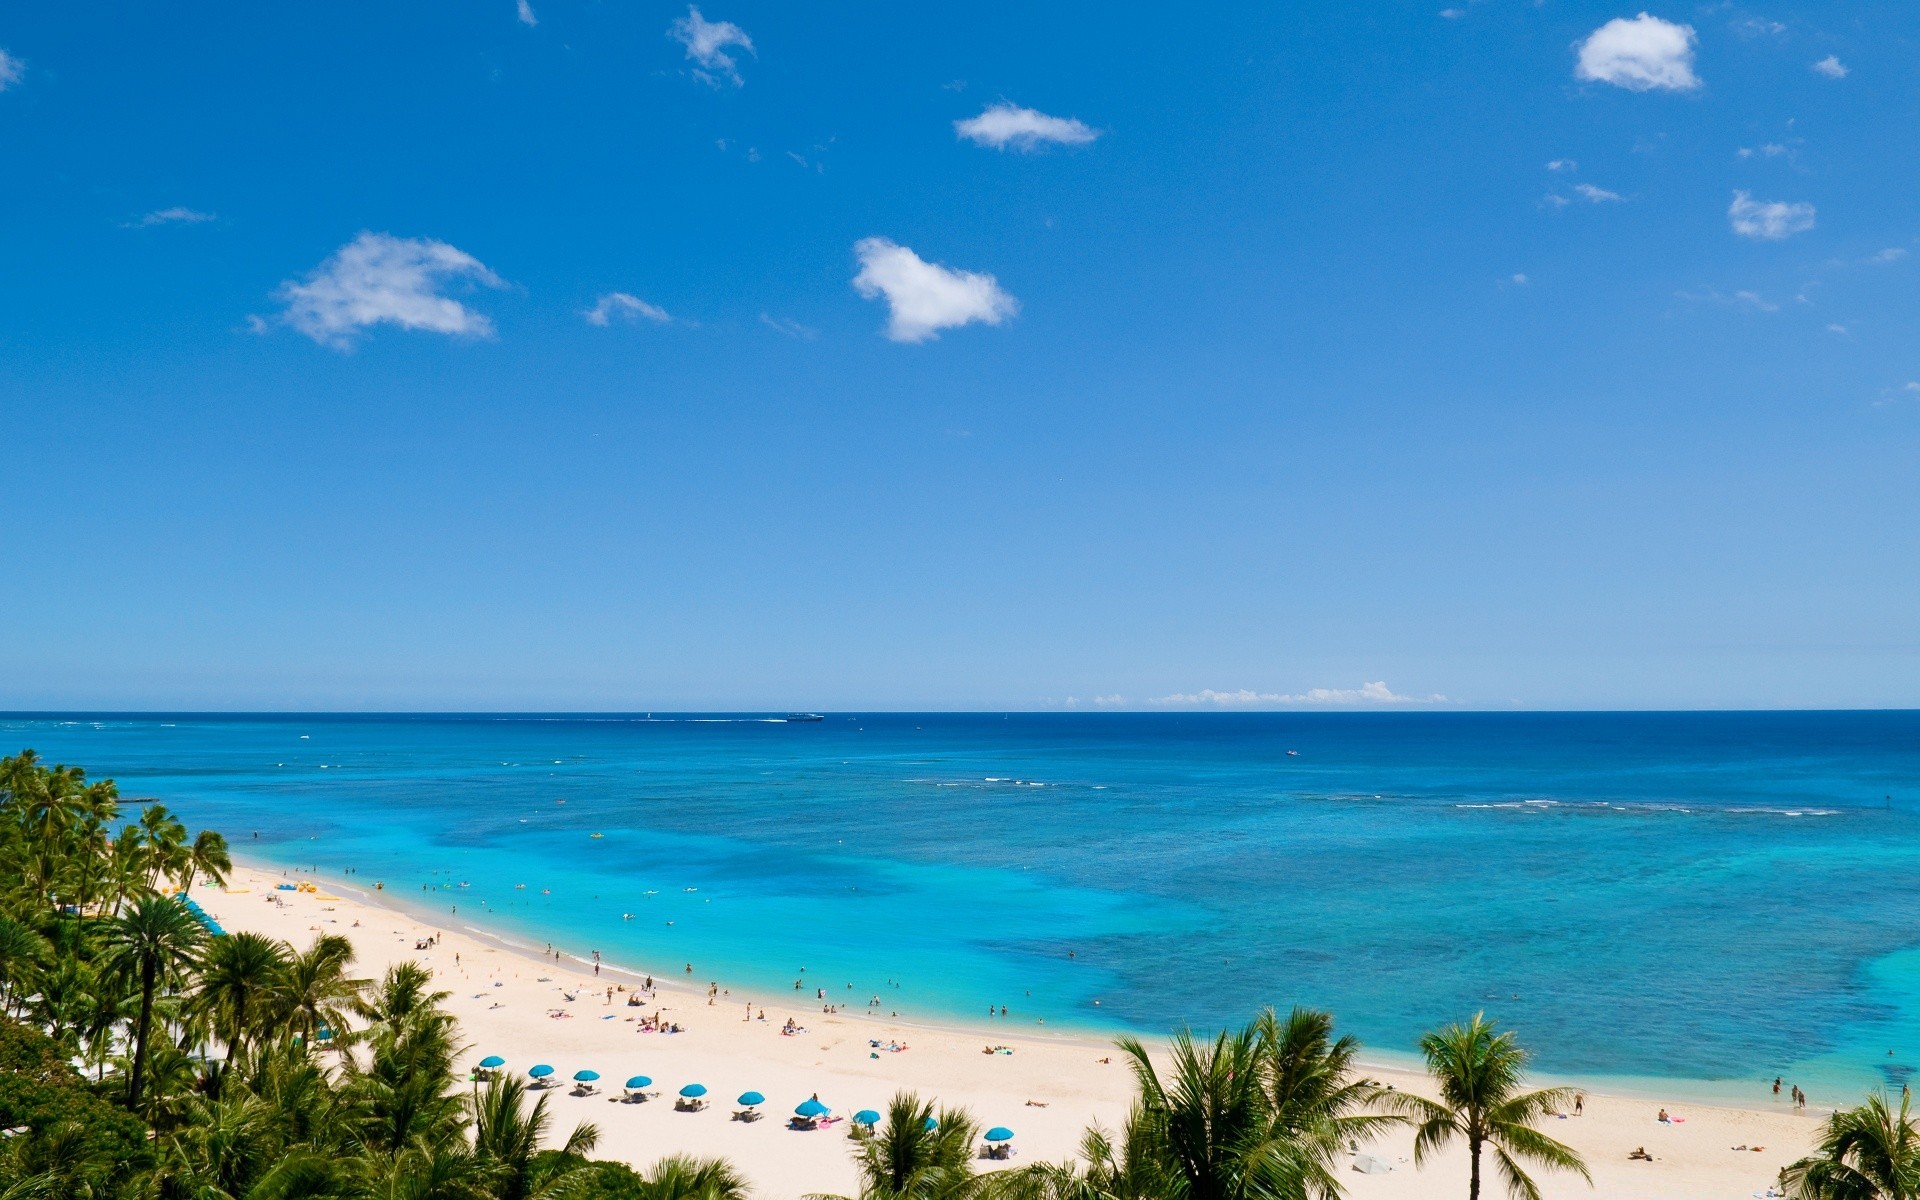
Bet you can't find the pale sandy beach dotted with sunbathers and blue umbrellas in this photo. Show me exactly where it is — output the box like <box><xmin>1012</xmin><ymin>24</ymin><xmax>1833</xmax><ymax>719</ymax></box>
<box><xmin>206</xmin><ymin>864</ymin><xmax>1824</xmax><ymax>1200</ymax></box>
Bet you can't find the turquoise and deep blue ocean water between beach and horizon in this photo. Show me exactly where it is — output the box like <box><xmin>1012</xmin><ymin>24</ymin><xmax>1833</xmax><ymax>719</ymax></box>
<box><xmin>0</xmin><ymin>712</ymin><xmax>1920</xmax><ymax>1089</ymax></box>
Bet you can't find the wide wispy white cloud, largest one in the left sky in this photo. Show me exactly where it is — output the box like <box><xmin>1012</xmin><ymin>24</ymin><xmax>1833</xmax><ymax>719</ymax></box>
<box><xmin>276</xmin><ymin>232</ymin><xmax>505</xmax><ymax>349</ymax></box>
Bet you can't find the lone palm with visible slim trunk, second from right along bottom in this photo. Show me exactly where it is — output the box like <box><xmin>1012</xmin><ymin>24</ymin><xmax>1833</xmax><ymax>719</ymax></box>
<box><xmin>1390</xmin><ymin>1014</ymin><xmax>1594</xmax><ymax>1200</ymax></box>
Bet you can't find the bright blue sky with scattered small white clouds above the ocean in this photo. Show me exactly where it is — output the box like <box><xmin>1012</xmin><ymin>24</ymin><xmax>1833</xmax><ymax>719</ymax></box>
<box><xmin>0</xmin><ymin>0</ymin><xmax>1920</xmax><ymax>710</ymax></box>
